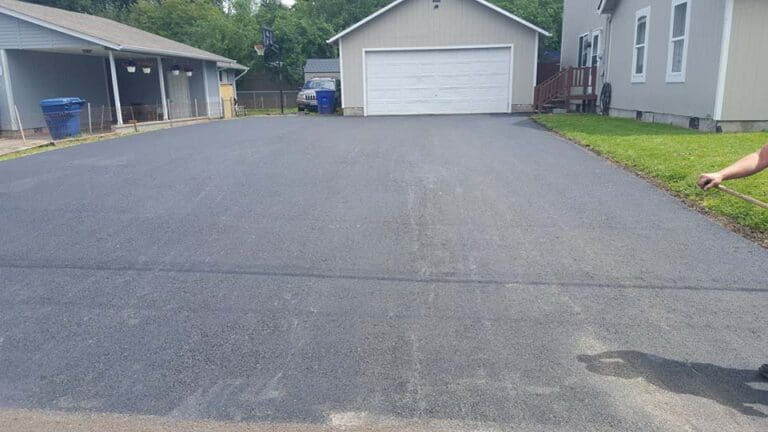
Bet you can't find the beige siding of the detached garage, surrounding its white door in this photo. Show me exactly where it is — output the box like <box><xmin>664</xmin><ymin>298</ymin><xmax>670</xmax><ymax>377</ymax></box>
<box><xmin>340</xmin><ymin>0</ymin><xmax>537</xmax><ymax>113</ymax></box>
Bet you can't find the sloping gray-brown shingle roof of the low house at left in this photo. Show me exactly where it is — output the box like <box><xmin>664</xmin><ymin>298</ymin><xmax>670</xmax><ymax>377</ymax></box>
<box><xmin>0</xmin><ymin>0</ymin><xmax>236</xmax><ymax>64</ymax></box>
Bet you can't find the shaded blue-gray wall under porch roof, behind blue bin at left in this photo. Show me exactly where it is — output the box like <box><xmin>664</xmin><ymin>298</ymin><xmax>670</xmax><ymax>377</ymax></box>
<box><xmin>5</xmin><ymin>50</ymin><xmax>109</xmax><ymax>130</ymax></box>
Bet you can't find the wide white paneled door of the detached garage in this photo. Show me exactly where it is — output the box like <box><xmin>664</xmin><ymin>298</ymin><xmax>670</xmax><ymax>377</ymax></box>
<box><xmin>365</xmin><ymin>47</ymin><xmax>512</xmax><ymax>115</ymax></box>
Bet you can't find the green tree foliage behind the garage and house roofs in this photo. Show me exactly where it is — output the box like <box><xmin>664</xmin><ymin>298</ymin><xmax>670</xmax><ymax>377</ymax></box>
<box><xmin>29</xmin><ymin>0</ymin><xmax>563</xmax><ymax>83</ymax></box>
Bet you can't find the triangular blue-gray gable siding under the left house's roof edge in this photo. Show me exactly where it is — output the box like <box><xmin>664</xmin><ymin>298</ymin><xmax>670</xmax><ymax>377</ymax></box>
<box><xmin>0</xmin><ymin>14</ymin><xmax>97</xmax><ymax>49</ymax></box>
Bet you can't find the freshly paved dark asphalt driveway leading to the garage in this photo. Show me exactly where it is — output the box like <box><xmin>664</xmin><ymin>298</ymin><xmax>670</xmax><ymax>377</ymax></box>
<box><xmin>0</xmin><ymin>116</ymin><xmax>768</xmax><ymax>431</ymax></box>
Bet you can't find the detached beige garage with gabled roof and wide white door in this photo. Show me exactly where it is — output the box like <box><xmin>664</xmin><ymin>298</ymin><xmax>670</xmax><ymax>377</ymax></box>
<box><xmin>328</xmin><ymin>0</ymin><xmax>549</xmax><ymax>115</ymax></box>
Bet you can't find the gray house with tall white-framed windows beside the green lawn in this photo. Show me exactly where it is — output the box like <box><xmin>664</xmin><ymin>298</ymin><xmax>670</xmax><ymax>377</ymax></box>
<box><xmin>561</xmin><ymin>0</ymin><xmax>768</xmax><ymax>131</ymax></box>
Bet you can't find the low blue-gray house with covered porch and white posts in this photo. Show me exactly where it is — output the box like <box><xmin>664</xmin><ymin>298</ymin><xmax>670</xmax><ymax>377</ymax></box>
<box><xmin>0</xmin><ymin>0</ymin><xmax>244</xmax><ymax>131</ymax></box>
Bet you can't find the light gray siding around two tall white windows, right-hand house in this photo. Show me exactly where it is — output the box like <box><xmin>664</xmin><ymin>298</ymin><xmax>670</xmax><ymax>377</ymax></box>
<box><xmin>607</xmin><ymin>0</ymin><xmax>725</xmax><ymax>119</ymax></box>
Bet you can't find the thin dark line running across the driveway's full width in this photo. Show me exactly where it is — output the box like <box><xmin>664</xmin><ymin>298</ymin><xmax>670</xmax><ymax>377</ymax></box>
<box><xmin>0</xmin><ymin>264</ymin><xmax>768</xmax><ymax>293</ymax></box>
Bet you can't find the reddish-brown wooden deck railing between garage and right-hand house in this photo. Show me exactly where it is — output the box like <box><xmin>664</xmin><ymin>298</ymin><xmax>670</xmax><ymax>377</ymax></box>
<box><xmin>533</xmin><ymin>67</ymin><xmax>597</xmax><ymax>111</ymax></box>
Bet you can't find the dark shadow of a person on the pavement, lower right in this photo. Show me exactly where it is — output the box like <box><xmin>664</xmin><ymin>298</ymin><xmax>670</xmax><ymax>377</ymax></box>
<box><xmin>577</xmin><ymin>351</ymin><xmax>768</xmax><ymax>417</ymax></box>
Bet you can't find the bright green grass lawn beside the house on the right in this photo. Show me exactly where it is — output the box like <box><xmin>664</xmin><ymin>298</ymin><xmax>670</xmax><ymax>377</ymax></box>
<box><xmin>534</xmin><ymin>114</ymin><xmax>768</xmax><ymax>237</ymax></box>
